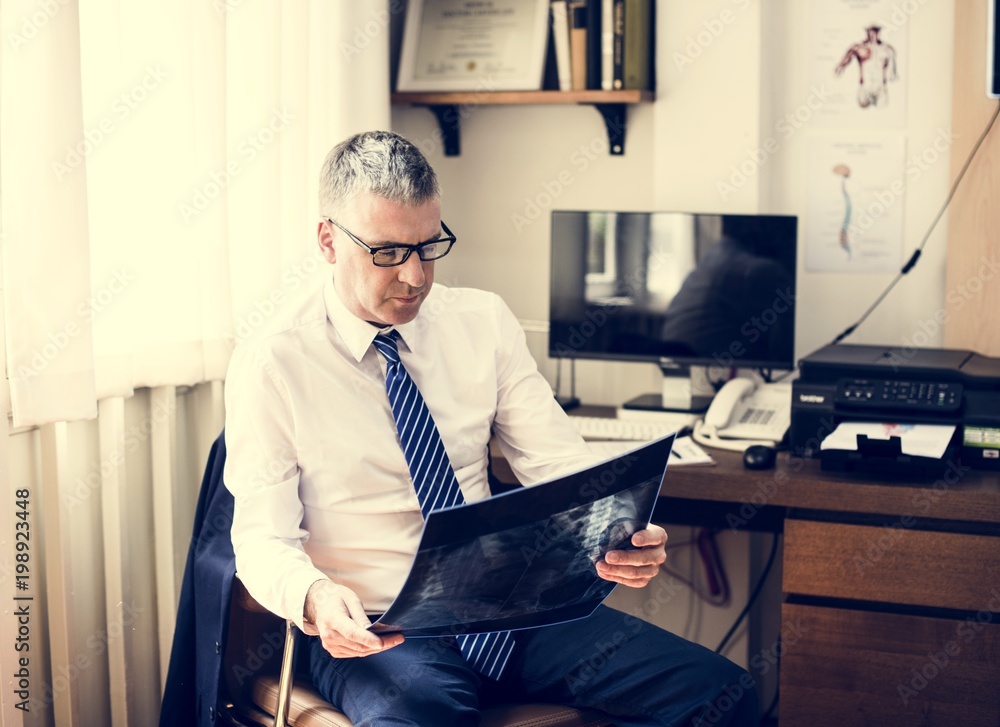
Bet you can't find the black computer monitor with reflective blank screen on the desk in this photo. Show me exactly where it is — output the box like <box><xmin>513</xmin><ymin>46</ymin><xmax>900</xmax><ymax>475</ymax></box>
<box><xmin>549</xmin><ymin>210</ymin><xmax>797</xmax><ymax>411</ymax></box>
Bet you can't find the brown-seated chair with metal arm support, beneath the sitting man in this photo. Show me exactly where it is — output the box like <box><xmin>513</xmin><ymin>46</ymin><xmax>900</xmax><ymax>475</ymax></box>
<box><xmin>221</xmin><ymin>578</ymin><xmax>613</xmax><ymax>727</ymax></box>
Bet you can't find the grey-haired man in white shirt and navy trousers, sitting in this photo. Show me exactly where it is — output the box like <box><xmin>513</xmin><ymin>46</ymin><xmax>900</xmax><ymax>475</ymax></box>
<box><xmin>225</xmin><ymin>132</ymin><xmax>757</xmax><ymax>727</ymax></box>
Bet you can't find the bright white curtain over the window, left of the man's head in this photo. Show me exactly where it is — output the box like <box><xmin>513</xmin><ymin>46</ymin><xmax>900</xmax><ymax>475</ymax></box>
<box><xmin>0</xmin><ymin>0</ymin><xmax>389</xmax><ymax>426</ymax></box>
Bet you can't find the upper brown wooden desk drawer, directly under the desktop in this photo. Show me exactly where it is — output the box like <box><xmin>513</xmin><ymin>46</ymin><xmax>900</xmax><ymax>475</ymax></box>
<box><xmin>783</xmin><ymin>519</ymin><xmax>1000</xmax><ymax>611</ymax></box>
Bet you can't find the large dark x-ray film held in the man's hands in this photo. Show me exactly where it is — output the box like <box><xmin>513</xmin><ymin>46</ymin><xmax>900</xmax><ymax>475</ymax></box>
<box><xmin>369</xmin><ymin>434</ymin><xmax>675</xmax><ymax>636</ymax></box>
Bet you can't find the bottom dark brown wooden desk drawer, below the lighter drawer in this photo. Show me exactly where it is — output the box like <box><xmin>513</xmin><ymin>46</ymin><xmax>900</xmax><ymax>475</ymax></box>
<box><xmin>780</xmin><ymin>603</ymin><xmax>1000</xmax><ymax>727</ymax></box>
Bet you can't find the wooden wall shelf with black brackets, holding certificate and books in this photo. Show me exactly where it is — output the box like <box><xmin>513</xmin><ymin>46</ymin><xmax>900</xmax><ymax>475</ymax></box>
<box><xmin>392</xmin><ymin>90</ymin><xmax>654</xmax><ymax>156</ymax></box>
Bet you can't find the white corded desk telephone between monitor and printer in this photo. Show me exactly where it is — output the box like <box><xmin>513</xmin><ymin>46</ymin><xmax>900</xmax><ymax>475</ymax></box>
<box><xmin>694</xmin><ymin>378</ymin><xmax>792</xmax><ymax>451</ymax></box>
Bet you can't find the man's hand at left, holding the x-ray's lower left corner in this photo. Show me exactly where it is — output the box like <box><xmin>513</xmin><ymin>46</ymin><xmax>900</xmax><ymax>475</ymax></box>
<box><xmin>303</xmin><ymin>580</ymin><xmax>403</xmax><ymax>659</ymax></box>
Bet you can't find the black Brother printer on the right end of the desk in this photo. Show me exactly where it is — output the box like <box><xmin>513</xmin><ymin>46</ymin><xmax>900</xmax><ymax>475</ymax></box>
<box><xmin>789</xmin><ymin>344</ymin><xmax>1000</xmax><ymax>475</ymax></box>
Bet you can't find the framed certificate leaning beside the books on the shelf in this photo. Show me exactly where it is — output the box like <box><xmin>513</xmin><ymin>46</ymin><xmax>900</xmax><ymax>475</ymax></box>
<box><xmin>396</xmin><ymin>0</ymin><xmax>549</xmax><ymax>91</ymax></box>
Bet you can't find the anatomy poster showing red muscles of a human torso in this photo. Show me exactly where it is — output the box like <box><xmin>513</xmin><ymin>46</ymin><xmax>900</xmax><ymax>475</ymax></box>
<box><xmin>809</xmin><ymin>0</ymin><xmax>908</xmax><ymax>128</ymax></box>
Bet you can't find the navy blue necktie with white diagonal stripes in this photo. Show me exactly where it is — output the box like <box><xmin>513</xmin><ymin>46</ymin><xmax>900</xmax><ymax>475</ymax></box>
<box><xmin>374</xmin><ymin>331</ymin><xmax>514</xmax><ymax>679</ymax></box>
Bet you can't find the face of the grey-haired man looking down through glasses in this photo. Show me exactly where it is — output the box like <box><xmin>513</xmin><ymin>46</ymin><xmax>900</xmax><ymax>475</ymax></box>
<box><xmin>319</xmin><ymin>193</ymin><xmax>443</xmax><ymax>326</ymax></box>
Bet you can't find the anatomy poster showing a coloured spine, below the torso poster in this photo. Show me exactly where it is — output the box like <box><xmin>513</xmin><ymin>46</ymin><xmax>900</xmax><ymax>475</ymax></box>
<box><xmin>806</xmin><ymin>132</ymin><xmax>906</xmax><ymax>273</ymax></box>
